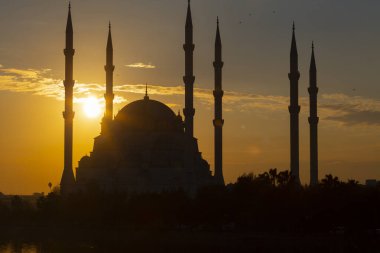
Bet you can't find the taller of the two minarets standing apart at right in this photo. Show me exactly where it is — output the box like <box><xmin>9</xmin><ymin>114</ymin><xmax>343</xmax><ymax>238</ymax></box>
<box><xmin>288</xmin><ymin>23</ymin><xmax>301</xmax><ymax>183</ymax></box>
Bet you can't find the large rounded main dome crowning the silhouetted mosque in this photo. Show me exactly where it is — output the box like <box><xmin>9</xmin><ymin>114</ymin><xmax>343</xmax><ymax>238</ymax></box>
<box><xmin>115</xmin><ymin>97</ymin><xmax>182</xmax><ymax>131</ymax></box>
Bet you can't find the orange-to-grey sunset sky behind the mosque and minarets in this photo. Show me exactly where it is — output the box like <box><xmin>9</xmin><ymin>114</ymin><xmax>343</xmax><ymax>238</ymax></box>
<box><xmin>0</xmin><ymin>0</ymin><xmax>380</xmax><ymax>194</ymax></box>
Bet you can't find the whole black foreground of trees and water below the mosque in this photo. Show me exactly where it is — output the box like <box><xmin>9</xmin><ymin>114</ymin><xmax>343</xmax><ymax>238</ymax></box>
<box><xmin>0</xmin><ymin>173</ymin><xmax>380</xmax><ymax>253</ymax></box>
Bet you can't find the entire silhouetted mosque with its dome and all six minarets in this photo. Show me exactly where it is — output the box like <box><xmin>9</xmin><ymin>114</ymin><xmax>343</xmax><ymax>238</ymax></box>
<box><xmin>60</xmin><ymin>0</ymin><xmax>319</xmax><ymax>194</ymax></box>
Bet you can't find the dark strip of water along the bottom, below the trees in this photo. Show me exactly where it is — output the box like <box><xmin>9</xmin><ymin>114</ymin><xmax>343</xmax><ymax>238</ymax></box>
<box><xmin>0</xmin><ymin>228</ymin><xmax>380</xmax><ymax>253</ymax></box>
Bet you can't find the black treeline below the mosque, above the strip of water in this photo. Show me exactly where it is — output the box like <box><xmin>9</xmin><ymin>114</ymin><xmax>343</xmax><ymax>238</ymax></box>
<box><xmin>0</xmin><ymin>169</ymin><xmax>380</xmax><ymax>233</ymax></box>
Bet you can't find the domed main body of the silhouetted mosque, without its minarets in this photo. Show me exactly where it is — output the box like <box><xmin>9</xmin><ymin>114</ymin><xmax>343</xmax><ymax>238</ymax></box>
<box><xmin>77</xmin><ymin>96</ymin><xmax>213</xmax><ymax>192</ymax></box>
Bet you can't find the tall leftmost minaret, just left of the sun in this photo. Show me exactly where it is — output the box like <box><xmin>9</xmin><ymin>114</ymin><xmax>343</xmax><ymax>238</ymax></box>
<box><xmin>61</xmin><ymin>4</ymin><xmax>75</xmax><ymax>194</ymax></box>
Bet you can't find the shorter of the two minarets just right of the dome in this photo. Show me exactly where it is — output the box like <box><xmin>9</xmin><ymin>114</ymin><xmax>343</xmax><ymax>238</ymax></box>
<box><xmin>213</xmin><ymin>18</ymin><xmax>224</xmax><ymax>185</ymax></box>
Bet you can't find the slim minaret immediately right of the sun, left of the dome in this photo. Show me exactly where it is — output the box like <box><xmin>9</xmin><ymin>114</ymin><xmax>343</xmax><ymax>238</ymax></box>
<box><xmin>102</xmin><ymin>22</ymin><xmax>115</xmax><ymax>133</ymax></box>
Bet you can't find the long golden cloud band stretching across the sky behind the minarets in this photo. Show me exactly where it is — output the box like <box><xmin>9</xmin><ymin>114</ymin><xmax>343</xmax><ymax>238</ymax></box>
<box><xmin>0</xmin><ymin>68</ymin><xmax>380</xmax><ymax>126</ymax></box>
